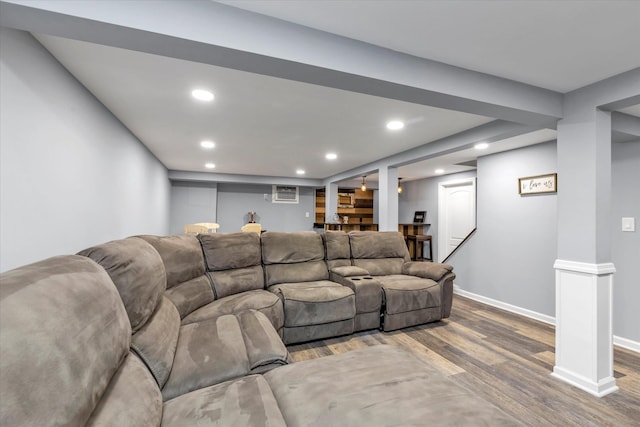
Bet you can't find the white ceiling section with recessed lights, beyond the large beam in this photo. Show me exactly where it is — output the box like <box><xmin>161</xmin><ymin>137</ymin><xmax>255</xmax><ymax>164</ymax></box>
<box><xmin>37</xmin><ymin>35</ymin><xmax>493</xmax><ymax>178</ymax></box>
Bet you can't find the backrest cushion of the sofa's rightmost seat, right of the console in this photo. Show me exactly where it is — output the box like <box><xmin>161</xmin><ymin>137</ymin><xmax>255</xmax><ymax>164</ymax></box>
<box><xmin>349</xmin><ymin>231</ymin><xmax>410</xmax><ymax>276</ymax></box>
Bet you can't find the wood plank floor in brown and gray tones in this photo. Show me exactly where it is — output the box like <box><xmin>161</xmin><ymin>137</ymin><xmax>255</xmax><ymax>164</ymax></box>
<box><xmin>289</xmin><ymin>295</ymin><xmax>640</xmax><ymax>427</ymax></box>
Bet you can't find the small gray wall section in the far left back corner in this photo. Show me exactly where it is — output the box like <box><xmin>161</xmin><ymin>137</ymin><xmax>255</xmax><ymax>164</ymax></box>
<box><xmin>169</xmin><ymin>182</ymin><xmax>218</xmax><ymax>234</ymax></box>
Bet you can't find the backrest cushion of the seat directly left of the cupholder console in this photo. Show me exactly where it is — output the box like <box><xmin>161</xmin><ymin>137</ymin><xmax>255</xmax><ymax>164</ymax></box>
<box><xmin>261</xmin><ymin>231</ymin><xmax>329</xmax><ymax>286</ymax></box>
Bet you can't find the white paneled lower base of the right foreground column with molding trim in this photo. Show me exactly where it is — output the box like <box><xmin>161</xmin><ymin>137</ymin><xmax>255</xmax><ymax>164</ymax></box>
<box><xmin>551</xmin><ymin>260</ymin><xmax>618</xmax><ymax>397</ymax></box>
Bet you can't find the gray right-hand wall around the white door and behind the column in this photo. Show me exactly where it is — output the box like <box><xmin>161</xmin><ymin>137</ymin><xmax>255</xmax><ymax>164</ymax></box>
<box><xmin>399</xmin><ymin>142</ymin><xmax>640</xmax><ymax>341</ymax></box>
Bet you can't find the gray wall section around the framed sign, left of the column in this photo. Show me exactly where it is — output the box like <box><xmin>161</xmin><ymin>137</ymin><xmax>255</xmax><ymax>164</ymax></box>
<box><xmin>458</xmin><ymin>142</ymin><xmax>562</xmax><ymax>316</ymax></box>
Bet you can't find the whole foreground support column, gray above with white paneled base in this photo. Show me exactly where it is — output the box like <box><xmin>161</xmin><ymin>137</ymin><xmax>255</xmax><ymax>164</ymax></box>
<box><xmin>552</xmin><ymin>101</ymin><xmax>618</xmax><ymax>397</ymax></box>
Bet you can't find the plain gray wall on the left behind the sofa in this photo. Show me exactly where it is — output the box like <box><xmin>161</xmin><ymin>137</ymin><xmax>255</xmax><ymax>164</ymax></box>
<box><xmin>0</xmin><ymin>28</ymin><xmax>169</xmax><ymax>271</ymax></box>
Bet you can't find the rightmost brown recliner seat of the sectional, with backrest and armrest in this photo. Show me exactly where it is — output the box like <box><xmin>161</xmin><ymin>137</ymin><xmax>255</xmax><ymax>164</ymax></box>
<box><xmin>344</xmin><ymin>231</ymin><xmax>455</xmax><ymax>331</ymax></box>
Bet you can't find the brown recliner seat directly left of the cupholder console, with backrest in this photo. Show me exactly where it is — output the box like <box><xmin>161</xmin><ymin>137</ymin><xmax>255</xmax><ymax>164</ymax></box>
<box><xmin>261</xmin><ymin>231</ymin><xmax>356</xmax><ymax>344</ymax></box>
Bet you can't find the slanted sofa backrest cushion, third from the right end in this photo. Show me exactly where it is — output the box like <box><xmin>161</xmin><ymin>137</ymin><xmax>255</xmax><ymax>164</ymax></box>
<box><xmin>198</xmin><ymin>233</ymin><xmax>264</xmax><ymax>299</ymax></box>
